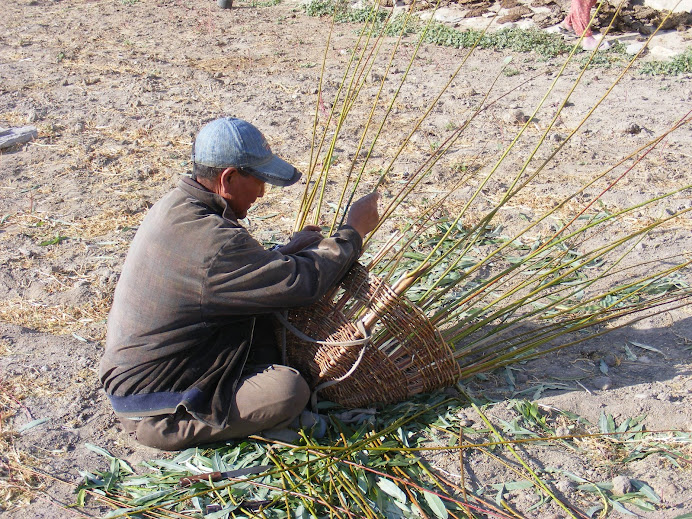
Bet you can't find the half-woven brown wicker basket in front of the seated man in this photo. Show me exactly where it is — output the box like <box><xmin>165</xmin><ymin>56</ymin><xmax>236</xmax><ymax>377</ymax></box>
<box><xmin>286</xmin><ymin>264</ymin><xmax>460</xmax><ymax>407</ymax></box>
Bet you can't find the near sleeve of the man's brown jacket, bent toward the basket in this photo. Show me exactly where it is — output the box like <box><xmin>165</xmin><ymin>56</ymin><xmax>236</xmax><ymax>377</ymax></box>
<box><xmin>202</xmin><ymin>226</ymin><xmax>362</xmax><ymax>314</ymax></box>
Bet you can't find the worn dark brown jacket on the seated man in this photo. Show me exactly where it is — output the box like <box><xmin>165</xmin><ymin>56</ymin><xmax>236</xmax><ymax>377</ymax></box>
<box><xmin>100</xmin><ymin>178</ymin><xmax>362</xmax><ymax>427</ymax></box>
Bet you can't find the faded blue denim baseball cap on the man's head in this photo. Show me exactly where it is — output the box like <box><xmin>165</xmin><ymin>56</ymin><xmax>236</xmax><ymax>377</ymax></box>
<box><xmin>192</xmin><ymin>117</ymin><xmax>301</xmax><ymax>186</ymax></box>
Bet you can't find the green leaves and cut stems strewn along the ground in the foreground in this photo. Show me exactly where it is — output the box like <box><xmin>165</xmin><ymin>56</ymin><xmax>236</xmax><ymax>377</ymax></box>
<box><xmin>77</xmin><ymin>394</ymin><xmax>692</xmax><ymax>519</ymax></box>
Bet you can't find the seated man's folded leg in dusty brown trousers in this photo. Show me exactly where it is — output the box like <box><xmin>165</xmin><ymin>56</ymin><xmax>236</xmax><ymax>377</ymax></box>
<box><xmin>123</xmin><ymin>365</ymin><xmax>310</xmax><ymax>450</ymax></box>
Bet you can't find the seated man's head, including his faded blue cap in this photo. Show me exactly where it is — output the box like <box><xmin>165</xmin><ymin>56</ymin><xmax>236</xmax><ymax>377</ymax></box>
<box><xmin>192</xmin><ymin>117</ymin><xmax>300</xmax><ymax>218</ymax></box>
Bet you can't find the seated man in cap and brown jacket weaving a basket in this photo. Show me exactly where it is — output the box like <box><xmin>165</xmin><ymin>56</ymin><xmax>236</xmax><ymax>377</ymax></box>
<box><xmin>100</xmin><ymin>118</ymin><xmax>379</xmax><ymax>450</ymax></box>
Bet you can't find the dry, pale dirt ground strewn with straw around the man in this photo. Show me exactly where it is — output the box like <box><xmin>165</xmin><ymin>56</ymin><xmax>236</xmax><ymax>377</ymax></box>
<box><xmin>0</xmin><ymin>0</ymin><xmax>692</xmax><ymax>519</ymax></box>
